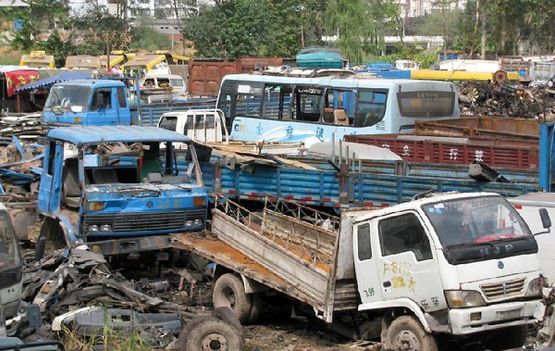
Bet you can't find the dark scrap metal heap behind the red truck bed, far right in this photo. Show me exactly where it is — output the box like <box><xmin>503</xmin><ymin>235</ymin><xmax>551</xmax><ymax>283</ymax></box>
<box><xmin>458</xmin><ymin>81</ymin><xmax>555</xmax><ymax>122</ymax></box>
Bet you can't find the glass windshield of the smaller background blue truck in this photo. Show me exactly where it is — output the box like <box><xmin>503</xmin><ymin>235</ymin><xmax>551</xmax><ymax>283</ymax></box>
<box><xmin>44</xmin><ymin>85</ymin><xmax>91</xmax><ymax>111</ymax></box>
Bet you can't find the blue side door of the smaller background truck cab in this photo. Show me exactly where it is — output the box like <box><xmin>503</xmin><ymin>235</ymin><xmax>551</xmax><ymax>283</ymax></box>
<box><xmin>88</xmin><ymin>88</ymin><xmax>120</xmax><ymax>126</ymax></box>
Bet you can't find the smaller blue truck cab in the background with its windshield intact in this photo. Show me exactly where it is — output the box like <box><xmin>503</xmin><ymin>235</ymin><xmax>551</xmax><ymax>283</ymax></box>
<box><xmin>42</xmin><ymin>79</ymin><xmax>136</xmax><ymax>126</ymax></box>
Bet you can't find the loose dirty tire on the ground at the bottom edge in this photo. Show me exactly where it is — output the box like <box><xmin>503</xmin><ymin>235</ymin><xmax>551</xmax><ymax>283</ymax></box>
<box><xmin>185</xmin><ymin>317</ymin><xmax>243</xmax><ymax>351</ymax></box>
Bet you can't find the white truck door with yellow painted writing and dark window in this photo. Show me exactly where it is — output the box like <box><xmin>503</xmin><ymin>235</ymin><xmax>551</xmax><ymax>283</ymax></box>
<box><xmin>371</xmin><ymin>211</ymin><xmax>447</xmax><ymax>312</ymax></box>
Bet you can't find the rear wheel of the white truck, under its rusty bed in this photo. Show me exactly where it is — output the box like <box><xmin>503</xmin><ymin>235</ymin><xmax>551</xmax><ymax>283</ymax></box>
<box><xmin>212</xmin><ymin>273</ymin><xmax>252</xmax><ymax>324</ymax></box>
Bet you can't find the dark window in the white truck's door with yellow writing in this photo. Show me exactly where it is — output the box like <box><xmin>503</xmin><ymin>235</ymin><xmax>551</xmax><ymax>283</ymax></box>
<box><xmin>378</xmin><ymin>213</ymin><xmax>432</xmax><ymax>261</ymax></box>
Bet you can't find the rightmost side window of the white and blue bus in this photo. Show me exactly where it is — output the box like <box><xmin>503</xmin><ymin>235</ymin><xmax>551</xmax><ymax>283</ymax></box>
<box><xmin>355</xmin><ymin>89</ymin><xmax>387</xmax><ymax>127</ymax></box>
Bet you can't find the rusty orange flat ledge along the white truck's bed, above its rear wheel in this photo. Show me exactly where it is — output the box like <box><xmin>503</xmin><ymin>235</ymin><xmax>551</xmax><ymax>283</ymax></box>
<box><xmin>170</xmin><ymin>232</ymin><xmax>318</xmax><ymax>303</ymax></box>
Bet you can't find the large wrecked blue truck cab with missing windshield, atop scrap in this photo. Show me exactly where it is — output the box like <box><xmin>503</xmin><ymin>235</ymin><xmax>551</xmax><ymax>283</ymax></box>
<box><xmin>37</xmin><ymin>126</ymin><xmax>208</xmax><ymax>258</ymax></box>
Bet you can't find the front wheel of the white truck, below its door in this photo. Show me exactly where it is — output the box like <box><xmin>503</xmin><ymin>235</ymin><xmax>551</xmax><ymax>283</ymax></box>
<box><xmin>382</xmin><ymin>316</ymin><xmax>438</xmax><ymax>351</ymax></box>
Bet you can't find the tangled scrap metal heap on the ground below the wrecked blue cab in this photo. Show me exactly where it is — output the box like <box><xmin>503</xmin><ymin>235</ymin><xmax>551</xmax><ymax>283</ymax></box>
<box><xmin>10</xmin><ymin>245</ymin><xmax>243</xmax><ymax>350</ymax></box>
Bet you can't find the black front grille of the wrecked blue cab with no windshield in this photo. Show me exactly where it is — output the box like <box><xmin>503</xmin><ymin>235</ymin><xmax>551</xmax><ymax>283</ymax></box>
<box><xmin>83</xmin><ymin>209</ymin><xmax>206</xmax><ymax>233</ymax></box>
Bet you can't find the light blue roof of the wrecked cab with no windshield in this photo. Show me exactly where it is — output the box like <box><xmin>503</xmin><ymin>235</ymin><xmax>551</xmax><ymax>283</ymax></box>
<box><xmin>47</xmin><ymin>126</ymin><xmax>191</xmax><ymax>146</ymax></box>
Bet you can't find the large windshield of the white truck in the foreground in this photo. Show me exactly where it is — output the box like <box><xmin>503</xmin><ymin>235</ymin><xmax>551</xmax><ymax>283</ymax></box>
<box><xmin>422</xmin><ymin>196</ymin><xmax>532</xmax><ymax>249</ymax></box>
